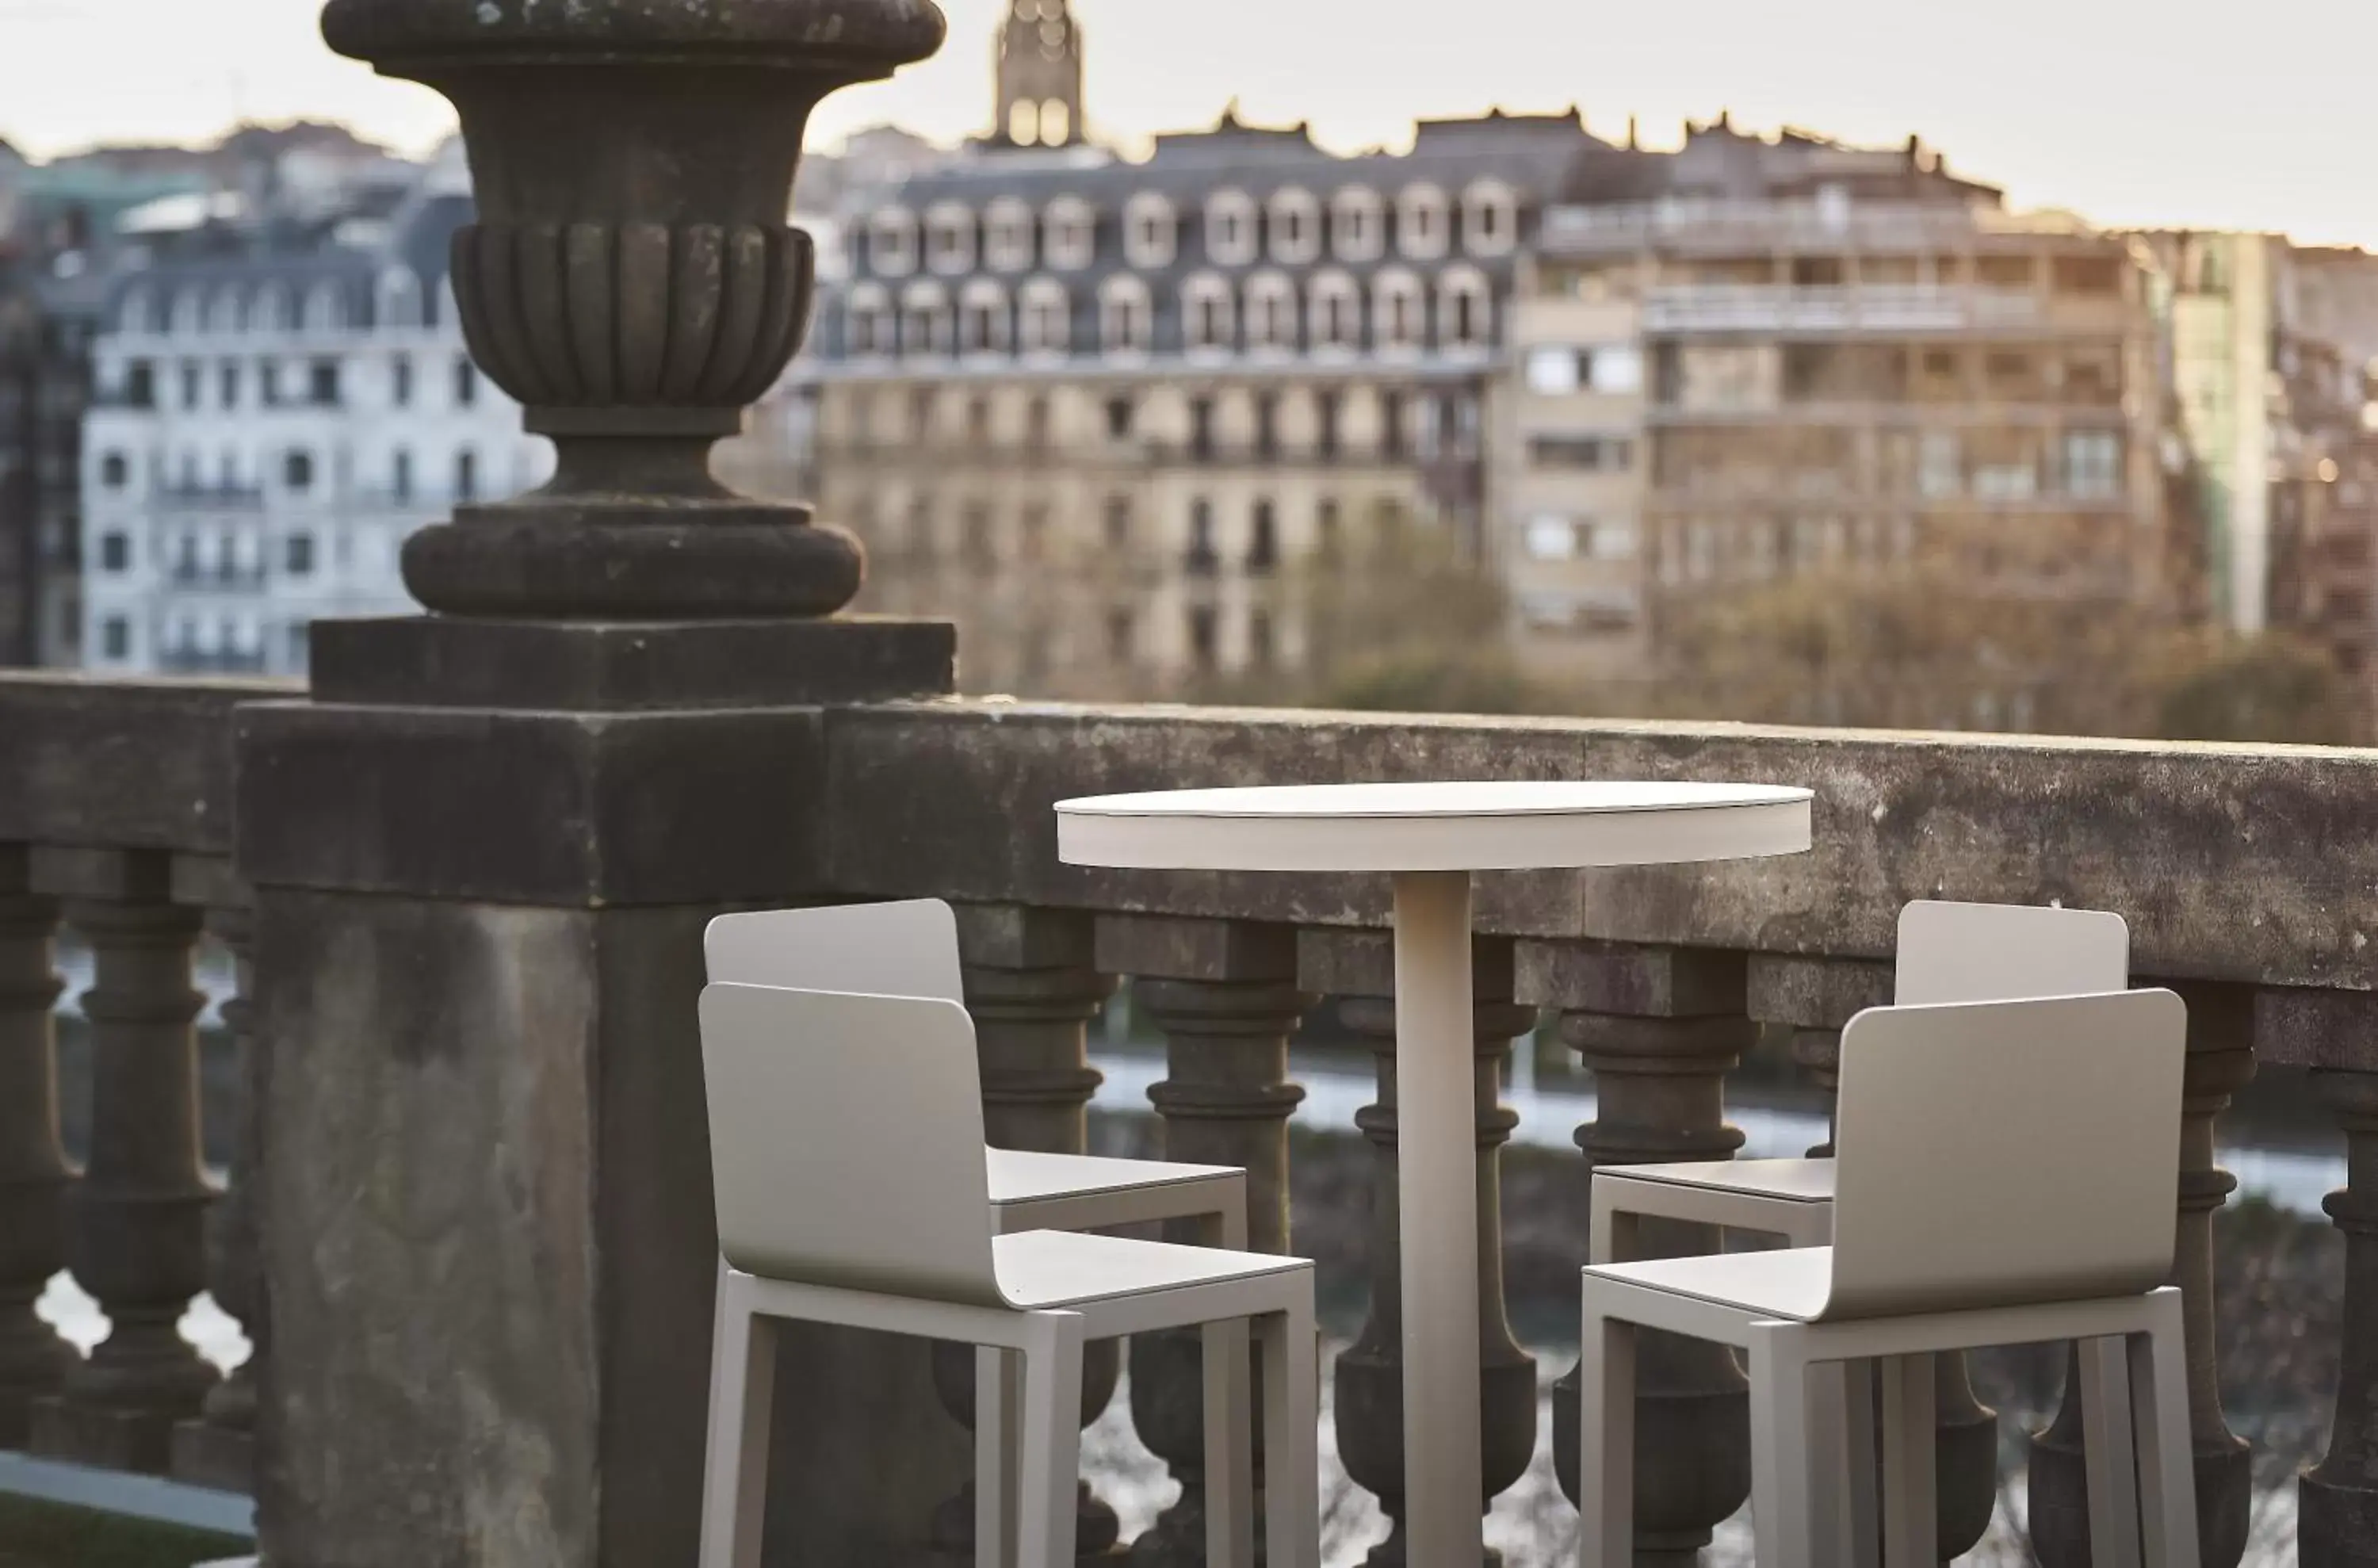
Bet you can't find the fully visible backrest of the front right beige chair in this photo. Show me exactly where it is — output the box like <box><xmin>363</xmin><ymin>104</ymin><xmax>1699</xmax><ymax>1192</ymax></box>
<box><xmin>1824</xmin><ymin>990</ymin><xmax>2188</xmax><ymax>1318</ymax></box>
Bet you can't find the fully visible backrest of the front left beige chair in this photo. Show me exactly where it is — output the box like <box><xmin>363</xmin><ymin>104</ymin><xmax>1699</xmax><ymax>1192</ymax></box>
<box><xmin>702</xmin><ymin>985</ymin><xmax>1004</xmax><ymax>1306</ymax></box>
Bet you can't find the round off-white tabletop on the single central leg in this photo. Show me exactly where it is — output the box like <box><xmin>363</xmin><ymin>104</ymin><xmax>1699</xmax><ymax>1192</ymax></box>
<box><xmin>1056</xmin><ymin>780</ymin><xmax>1814</xmax><ymax>871</ymax></box>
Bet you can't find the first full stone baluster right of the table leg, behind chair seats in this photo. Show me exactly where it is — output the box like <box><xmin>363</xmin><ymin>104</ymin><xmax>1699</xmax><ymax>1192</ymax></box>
<box><xmin>1520</xmin><ymin>943</ymin><xmax>1757</xmax><ymax>1568</ymax></box>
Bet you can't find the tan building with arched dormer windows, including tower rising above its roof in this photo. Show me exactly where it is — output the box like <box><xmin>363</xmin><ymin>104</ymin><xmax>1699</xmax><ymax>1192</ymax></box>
<box><xmin>797</xmin><ymin>0</ymin><xmax>1593</xmax><ymax>697</ymax></box>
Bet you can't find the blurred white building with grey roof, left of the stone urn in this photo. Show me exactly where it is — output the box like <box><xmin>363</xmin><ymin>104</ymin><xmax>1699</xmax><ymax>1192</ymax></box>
<box><xmin>83</xmin><ymin>148</ymin><xmax>552</xmax><ymax>673</ymax></box>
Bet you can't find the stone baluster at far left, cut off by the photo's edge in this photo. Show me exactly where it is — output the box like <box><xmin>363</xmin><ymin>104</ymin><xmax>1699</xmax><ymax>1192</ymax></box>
<box><xmin>0</xmin><ymin>845</ymin><xmax>74</xmax><ymax>1449</ymax></box>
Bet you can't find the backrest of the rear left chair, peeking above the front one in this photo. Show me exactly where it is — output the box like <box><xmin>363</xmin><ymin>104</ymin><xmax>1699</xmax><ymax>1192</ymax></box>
<box><xmin>702</xmin><ymin>900</ymin><xmax>965</xmax><ymax>1002</ymax></box>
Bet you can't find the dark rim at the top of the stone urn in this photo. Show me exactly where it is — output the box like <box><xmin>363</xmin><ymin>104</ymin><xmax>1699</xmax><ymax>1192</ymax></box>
<box><xmin>321</xmin><ymin>0</ymin><xmax>949</xmax><ymax>71</ymax></box>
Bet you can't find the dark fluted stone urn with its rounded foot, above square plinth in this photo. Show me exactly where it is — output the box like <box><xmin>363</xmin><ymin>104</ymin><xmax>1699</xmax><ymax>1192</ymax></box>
<box><xmin>321</xmin><ymin>0</ymin><xmax>944</xmax><ymax>618</ymax></box>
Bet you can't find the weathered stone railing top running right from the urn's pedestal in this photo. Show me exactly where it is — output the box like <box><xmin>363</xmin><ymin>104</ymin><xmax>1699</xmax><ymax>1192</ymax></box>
<box><xmin>828</xmin><ymin>699</ymin><xmax>2378</xmax><ymax>990</ymax></box>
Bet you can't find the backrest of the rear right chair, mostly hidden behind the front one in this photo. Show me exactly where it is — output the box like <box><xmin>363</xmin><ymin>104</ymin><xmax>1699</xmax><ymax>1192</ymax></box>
<box><xmin>1893</xmin><ymin>900</ymin><xmax>2131</xmax><ymax>1007</ymax></box>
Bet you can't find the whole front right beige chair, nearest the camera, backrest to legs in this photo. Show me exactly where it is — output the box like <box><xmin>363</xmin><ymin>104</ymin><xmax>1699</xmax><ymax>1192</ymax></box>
<box><xmin>1579</xmin><ymin>990</ymin><xmax>2197</xmax><ymax>1568</ymax></box>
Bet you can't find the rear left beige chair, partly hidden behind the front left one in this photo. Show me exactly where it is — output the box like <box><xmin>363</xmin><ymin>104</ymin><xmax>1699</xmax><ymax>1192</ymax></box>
<box><xmin>704</xmin><ymin>900</ymin><xmax>1246</xmax><ymax>1568</ymax></box>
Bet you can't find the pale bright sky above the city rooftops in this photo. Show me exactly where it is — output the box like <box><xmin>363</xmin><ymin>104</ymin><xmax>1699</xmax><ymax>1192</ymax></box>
<box><xmin>13</xmin><ymin>0</ymin><xmax>2378</xmax><ymax>247</ymax></box>
